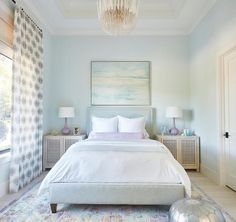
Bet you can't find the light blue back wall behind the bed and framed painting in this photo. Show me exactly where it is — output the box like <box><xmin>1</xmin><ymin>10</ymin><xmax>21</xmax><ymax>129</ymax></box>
<box><xmin>44</xmin><ymin>36</ymin><xmax>190</xmax><ymax>133</ymax></box>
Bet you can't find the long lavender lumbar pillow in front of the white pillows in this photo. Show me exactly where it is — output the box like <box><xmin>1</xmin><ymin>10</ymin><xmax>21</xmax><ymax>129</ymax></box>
<box><xmin>89</xmin><ymin>132</ymin><xmax>144</xmax><ymax>140</ymax></box>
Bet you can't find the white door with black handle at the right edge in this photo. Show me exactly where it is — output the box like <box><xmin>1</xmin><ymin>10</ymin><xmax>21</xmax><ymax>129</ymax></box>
<box><xmin>223</xmin><ymin>48</ymin><xmax>236</xmax><ymax>190</ymax></box>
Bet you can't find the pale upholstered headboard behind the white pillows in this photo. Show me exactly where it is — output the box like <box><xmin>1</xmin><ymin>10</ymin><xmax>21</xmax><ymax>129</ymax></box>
<box><xmin>87</xmin><ymin>106</ymin><xmax>154</xmax><ymax>136</ymax></box>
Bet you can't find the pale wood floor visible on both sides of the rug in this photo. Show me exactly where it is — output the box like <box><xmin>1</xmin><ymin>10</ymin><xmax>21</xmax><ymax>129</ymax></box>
<box><xmin>0</xmin><ymin>172</ymin><xmax>236</xmax><ymax>221</ymax></box>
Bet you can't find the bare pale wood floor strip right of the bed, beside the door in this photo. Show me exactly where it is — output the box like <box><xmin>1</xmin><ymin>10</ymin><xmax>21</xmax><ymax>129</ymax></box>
<box><xmin>188</xmin><ymin>172</ymin><xmax>236</xmax><ymax>221</ymax></box>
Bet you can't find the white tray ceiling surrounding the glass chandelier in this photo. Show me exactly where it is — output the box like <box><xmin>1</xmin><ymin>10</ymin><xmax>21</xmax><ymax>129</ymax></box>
<box><xmin>21</xmin><ymin>0</ymin><xmax>216</xmax><ymax>35</ymax></box>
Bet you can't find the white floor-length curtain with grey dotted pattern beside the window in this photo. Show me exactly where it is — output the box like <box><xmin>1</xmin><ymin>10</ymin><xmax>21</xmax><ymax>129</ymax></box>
<box><xmin>10</xmin><ymin>7</ymin><xmax>43</xmax><ymax>192</ymax></box>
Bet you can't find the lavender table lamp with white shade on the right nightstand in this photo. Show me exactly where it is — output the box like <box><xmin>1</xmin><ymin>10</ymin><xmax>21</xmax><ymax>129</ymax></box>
<box><xmin>166</xmin><ymin>106</ymin><xmax>183</xmax><ymax>136</ymax></box>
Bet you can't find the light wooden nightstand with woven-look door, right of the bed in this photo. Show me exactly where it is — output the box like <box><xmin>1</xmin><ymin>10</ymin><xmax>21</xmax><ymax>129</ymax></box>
<box><xmin>157</xmin><ymin>135</ymin><xmax>200</xmax><ymax>172</ymax></box>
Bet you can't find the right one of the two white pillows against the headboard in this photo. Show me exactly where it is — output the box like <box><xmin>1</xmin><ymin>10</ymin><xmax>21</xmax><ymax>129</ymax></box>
<box><xmin>118</xmin><ymin>116</ymin><xmax>145</xmax><ymax>133</ymax></box>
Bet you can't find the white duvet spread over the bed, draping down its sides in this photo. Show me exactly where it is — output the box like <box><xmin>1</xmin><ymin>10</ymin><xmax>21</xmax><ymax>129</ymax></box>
<box><xmin>38</xmin><ymin>139</ymin><xmax>191</xmax><ymax>196</ymax></box>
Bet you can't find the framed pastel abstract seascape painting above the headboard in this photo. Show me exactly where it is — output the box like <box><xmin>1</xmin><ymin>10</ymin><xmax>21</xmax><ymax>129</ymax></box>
<box><xmin>91</xmin><ymin>61</ymin><xmax>151</xmax><ymax>106</ymax></box>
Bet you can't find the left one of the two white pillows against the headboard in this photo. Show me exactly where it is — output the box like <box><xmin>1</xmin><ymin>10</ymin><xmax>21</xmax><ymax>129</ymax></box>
<box><xmin>92</xmin><ymin>116</ymin><xmax>118</xmax><ymax>133</ymax></box>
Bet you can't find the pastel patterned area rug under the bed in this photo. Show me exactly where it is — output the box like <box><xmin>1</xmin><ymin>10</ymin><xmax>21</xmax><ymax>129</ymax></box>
<box><xmin>0</xmin><ymin>184</ymin><xmax>234</xmax><ymax>222</ymax></box>
